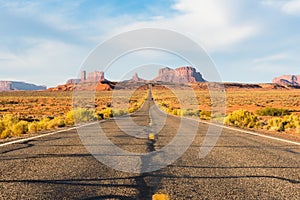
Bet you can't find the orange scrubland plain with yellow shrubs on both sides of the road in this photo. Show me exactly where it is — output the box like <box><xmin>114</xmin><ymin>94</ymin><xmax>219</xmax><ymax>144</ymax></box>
<box><xmin>0</xmin><ymin>84</ymin><xmax>300</xmax><ymax>141</ymax></box>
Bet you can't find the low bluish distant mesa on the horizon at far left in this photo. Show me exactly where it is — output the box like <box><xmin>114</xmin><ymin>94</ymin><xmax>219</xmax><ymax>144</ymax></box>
<box><xmin>0</xmin><ymin>81</ymin><xmax>47</xmax><ymax>92</ymax></box>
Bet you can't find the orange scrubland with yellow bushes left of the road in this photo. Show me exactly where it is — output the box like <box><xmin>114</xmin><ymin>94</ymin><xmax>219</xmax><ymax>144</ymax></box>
<box><xmin>0</xmin><ymin>90</ymin><xmax>147</xmax><ymax>138</ymax></box>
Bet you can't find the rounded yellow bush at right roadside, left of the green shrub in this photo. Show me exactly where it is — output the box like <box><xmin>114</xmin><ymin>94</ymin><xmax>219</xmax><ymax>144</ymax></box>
<box><xmin>224</xmin><ymin>110</ymin><xmax>259</xmax><ymax>128</ymax></box>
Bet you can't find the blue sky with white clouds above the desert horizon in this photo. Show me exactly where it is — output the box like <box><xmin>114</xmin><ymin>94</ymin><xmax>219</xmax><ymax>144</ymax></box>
<box><xmin>0</xmin><ymin>0</ymin><xmax>300</xmax><ymax>86</ymax></box>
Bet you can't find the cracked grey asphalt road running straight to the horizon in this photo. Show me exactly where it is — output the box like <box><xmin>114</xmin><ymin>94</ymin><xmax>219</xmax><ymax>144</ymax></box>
<box><xmin>0</xmin><ymin>91</ymin><xmax>300</xmax><ymax>200</ymax></box>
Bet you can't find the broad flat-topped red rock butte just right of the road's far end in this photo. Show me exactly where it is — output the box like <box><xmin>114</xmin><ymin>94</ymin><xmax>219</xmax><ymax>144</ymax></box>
<box><xmin>153</xmin><ymin>66</ymin><xmax>205</xmax><ymax>83</ymax></box>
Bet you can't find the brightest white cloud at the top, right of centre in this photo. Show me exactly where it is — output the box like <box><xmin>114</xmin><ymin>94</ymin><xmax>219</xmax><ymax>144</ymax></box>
<box><xmin>109</xmin><ymin>0</ymin><xmax>259</xmax><ymax>52</ymax></box>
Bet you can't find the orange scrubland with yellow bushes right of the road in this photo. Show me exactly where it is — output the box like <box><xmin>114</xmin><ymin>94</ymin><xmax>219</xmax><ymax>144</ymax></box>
<box><xmin>152</xmin><ymin>83</ymin><xmax>300</xmax><ymax>137</ymax></box>
